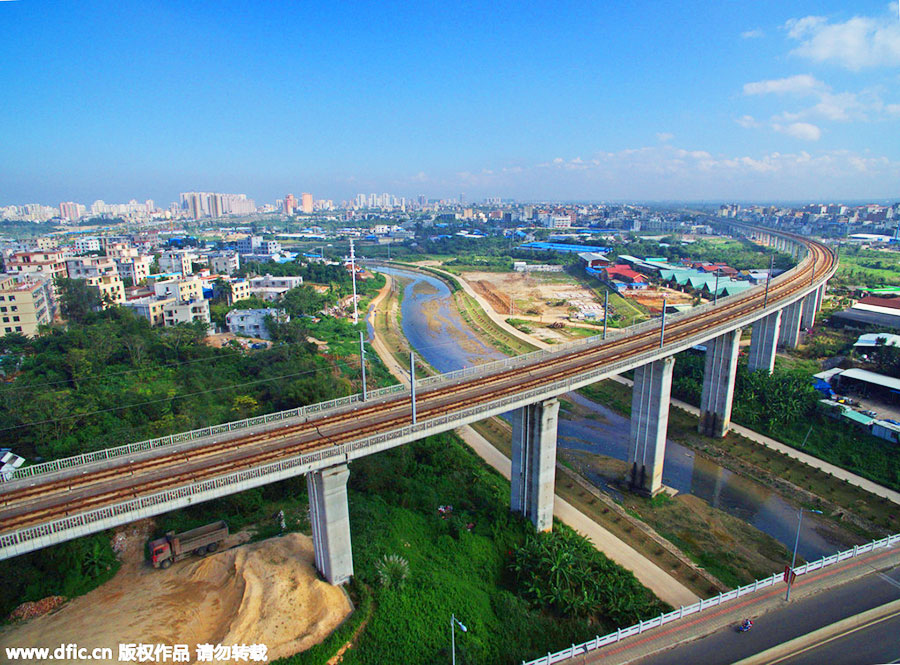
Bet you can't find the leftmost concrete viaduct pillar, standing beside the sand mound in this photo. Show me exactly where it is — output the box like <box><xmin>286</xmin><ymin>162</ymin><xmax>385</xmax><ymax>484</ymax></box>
<box><xmin>306</xmin><ymin>464</ymin><xmax>353</xmax><ymax>584</ymax></box>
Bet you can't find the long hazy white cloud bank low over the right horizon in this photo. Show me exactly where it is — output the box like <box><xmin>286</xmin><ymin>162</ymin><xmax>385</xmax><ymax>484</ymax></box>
<box><xmin>445</xmin><ymin>143</ymin><xmax>900</xmax><ymax>200</ymax></box>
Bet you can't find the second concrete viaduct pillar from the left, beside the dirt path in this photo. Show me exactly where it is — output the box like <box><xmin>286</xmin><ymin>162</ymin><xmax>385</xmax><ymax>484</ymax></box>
<box><xmin>510</xmin><ymin>399</ymin><xmax>559</xmax><ymax>531</ymax></box>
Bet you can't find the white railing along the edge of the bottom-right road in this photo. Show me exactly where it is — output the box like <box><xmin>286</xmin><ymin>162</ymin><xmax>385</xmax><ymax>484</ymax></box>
<box><xmin>522</xmin><ymin>534</ymin><xmax>900</xmax><ymax>665</ymax></box>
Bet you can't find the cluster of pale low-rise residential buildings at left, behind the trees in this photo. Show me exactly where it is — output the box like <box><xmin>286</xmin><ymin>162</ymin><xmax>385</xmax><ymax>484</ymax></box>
<box><xmin>0</xmin><ymin>236</ymin><xmax>303</xmax><ymax>336</ymax></box>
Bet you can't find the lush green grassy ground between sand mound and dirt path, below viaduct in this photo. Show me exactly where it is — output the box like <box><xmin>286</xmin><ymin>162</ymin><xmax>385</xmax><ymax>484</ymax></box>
<box><xmin>281</xmin><ymin>434</ymin><xmax>664</xmax><ymax>665</ymax></box>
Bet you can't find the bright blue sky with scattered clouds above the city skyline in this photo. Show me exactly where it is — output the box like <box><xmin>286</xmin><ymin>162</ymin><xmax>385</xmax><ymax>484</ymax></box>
<box><xmin>0</xmin><ymin>0</ymin><xmax>900</xmax><ymax>205</ymax></box>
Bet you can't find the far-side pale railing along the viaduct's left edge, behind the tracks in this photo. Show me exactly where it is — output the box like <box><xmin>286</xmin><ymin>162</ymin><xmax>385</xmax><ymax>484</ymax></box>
<box><xmin>12</xmin><ymin>228</ymin><xmax>806</xmax><ymax>480</ymax></box>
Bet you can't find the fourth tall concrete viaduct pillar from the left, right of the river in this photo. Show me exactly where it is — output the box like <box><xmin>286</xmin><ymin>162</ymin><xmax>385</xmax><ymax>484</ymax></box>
<box><xmin>697</xmin><ymin>328</ymin><xmax>741</xmax><ymax>438</ymax></box>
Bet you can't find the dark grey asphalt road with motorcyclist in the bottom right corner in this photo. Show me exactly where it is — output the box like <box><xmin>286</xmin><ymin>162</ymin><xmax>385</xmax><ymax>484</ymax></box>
<box><xmin>636</xmin><ymin>567</ymin><xmax>900</xmax><ymax>665</ymax></box>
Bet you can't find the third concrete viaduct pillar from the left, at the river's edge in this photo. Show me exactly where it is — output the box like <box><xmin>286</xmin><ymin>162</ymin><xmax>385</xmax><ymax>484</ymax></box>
<box><xmin>628</xmin><ymin>356</ymin><xmax>675</xmax><ymax>496</ymax></box>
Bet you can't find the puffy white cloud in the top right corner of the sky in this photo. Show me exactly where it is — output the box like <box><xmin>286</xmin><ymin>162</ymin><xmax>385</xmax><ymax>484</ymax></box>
<box><xmin>784</xmin><ymin>15</ymin><xmax>900</xmax><ymax>71</ymax></box>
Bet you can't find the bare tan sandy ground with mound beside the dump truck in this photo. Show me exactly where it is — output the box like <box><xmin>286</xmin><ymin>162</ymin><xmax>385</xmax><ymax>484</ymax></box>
<box><xmin>0</xmin><ymin>520</ymin><xmax>351</xmax><ymax>663</ymax></box>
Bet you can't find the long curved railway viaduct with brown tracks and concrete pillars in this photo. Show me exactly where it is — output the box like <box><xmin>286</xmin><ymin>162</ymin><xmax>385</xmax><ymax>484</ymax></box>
<box><xmin>0</xmin><ymin>224</ymin><xmax>837</xmax><ymax>583</ymax></box>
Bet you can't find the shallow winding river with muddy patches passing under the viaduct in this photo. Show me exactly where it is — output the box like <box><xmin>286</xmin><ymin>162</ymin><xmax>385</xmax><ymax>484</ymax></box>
<box><xmin>370</xmin><ymin>267</ymin><xmax>846</xmax><ymax>560</ymax></box>
